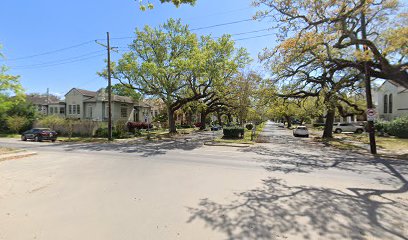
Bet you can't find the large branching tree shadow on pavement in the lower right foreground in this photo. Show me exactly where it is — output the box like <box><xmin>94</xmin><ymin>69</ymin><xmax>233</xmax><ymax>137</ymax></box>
<box><xmin>188</xmin><ymin>174</ymin><xmax>408</xmax><ymax>240</ymax></box>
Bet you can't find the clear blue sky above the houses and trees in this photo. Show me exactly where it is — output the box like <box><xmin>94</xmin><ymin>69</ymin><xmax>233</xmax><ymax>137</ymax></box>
<box><xmin>0</xmin><ymin>0</ymin><xmax>275</xmax><ymax>95</ymax></box>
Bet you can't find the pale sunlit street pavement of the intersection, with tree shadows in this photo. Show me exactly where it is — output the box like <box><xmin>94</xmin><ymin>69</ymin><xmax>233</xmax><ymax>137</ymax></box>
<box><xmin>0</xmin><ymin>122</ymin><xmax>408</xmax><ymax>240</ymax></box>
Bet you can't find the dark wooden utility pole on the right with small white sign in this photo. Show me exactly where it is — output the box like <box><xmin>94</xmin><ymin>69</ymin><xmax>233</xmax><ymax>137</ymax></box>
<box><xmin>361</xmin><ymin>9</ymin><xmax>377</xmax><ymax>154</ymax></box>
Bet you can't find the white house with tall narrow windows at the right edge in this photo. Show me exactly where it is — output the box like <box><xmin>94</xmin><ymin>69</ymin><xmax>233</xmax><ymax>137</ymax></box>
<box><xmin>377</xmin><ymin>81</ymin><xmax>408</xmax><ymax>121</ymax></box>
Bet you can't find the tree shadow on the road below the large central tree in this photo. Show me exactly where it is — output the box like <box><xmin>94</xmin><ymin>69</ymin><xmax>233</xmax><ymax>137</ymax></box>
<box><xmin>59</xmin><ymin>134</ymin><xmax>212</xmax><ymax>157</ymax></box>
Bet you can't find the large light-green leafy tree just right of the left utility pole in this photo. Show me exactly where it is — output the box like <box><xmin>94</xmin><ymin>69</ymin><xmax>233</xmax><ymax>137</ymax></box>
<box><xmin>112</xmin><ymin>19</ymin><xmax>248</xmax><ymax>132</ymax></box>
